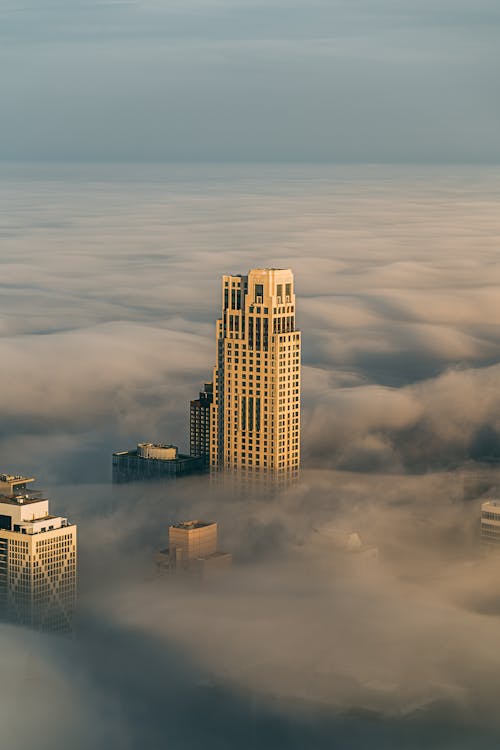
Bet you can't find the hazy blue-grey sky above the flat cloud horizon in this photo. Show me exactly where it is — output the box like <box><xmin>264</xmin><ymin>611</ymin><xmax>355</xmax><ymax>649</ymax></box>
<box><xmin>0</xmin><ymin>0</ymin><xmax>500</xmax><ymax>164</ymax></box>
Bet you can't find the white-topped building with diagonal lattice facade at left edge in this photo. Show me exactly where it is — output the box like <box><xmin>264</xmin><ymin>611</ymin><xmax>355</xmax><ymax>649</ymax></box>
<box><xmin>0</xmin><ymin>494</ymin><xmax>77</xmax><ymax>632</ymax></box>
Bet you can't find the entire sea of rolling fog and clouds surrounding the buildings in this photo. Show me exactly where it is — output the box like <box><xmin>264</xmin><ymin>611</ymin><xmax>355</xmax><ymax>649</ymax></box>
<box><xmin>0</xmin><ymin>164</ymin><xmax>500</xmax><ymax>750</ymax></box>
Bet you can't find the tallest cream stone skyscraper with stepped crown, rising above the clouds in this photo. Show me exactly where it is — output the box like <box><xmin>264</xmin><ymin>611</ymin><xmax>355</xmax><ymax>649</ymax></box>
<box><xmin>210</xmin><ymin>268</ymin><xmax>301</xmax><ymax>484</ymax></box>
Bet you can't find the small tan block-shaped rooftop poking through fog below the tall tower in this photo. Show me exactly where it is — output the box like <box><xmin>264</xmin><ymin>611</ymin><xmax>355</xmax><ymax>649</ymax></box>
<box><xmin>156</xmin><ymin>520</ymin><xmax>232</xmax><ymax>578</ymax></box>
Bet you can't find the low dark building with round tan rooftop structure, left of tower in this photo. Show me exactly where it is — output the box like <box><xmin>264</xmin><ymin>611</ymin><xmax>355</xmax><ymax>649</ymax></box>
<box><xmin>113</xmin><ymin>443</ymin><xmax>205</xmax><ymax>484</ymax></box>
